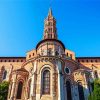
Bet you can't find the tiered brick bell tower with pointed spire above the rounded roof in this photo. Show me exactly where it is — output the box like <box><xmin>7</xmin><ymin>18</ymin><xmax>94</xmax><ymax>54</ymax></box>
<box><xmin>43</xmin><ymin>8</ymin><xmax>57</xmax><ymax>39</ymax></box>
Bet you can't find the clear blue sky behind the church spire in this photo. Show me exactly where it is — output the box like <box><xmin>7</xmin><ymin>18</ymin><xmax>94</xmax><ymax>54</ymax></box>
<box><xmin>0</xmin><ymin>0</ymin><xmax>100</xmax><ymax>57</ymax></box>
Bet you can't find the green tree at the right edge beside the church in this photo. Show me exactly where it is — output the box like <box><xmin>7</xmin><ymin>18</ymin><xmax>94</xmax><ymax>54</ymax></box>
<box><xmin>88</xmin><ymin>79</ymin><xmax>100</xmax><ymax>100</ymax></box>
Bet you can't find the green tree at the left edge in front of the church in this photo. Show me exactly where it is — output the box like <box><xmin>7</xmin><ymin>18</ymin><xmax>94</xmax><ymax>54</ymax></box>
<box><xmin>0</xmin><ymin>81</ymin><xmax>9</xmax><ymax>100</ymax></box>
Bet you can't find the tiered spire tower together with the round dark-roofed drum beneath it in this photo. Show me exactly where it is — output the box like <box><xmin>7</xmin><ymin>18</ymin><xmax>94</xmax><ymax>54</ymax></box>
<box><xmin>36</xmin><ymin>9</ymin><xmax>65</xmax><ymax>56</ymax></box>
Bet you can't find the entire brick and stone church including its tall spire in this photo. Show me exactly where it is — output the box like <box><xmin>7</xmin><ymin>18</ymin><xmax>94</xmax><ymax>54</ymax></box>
<box><xmin>0</xmin><ymin>9</ymin><xmax>100</xmax><ymax>100</ymax></box>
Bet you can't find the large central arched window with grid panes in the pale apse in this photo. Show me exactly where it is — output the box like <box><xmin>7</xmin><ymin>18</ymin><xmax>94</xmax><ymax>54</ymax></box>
<box><xmin>42</xmin><ymin>70</ymin><xmax>50</xmax><ymax>94</ymax></box>
